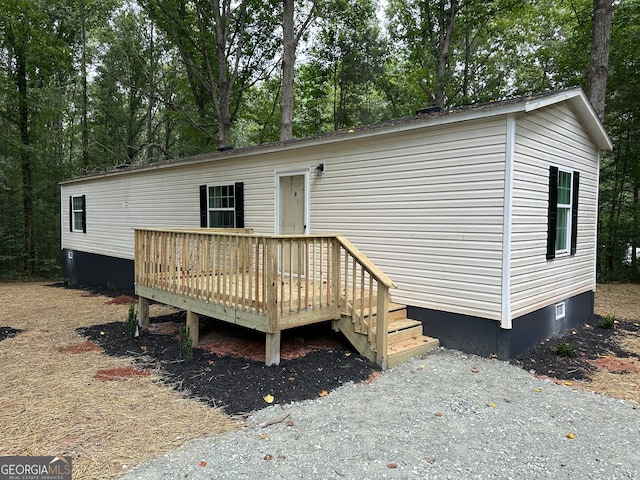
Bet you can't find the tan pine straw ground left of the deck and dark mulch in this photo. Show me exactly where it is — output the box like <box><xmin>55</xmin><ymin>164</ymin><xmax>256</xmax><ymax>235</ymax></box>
<box><xmin>0</xmin><ymin>283</ymin><xmax>237</xmax><ymax>479</ymax></box>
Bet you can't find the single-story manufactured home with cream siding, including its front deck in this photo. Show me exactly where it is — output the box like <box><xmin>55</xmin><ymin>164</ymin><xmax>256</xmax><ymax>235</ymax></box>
<box><xmin>61</xmin><ymin>88</ymin><xmax>612</xmax><ymax>363</ymax></box>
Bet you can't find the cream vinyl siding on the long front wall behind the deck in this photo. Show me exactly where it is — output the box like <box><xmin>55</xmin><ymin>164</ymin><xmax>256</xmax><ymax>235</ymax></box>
<box><xmin>62</xmin><ymin>118</ymin><xmax>506</xmax><ymax>320</ymax></box>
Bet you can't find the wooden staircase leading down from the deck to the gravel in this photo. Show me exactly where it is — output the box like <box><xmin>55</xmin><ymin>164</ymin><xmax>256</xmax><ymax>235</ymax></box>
<box><xmin>334</xmin><ymin>299</ymin><xmax>440</xmax><ymax>368</ymax></box>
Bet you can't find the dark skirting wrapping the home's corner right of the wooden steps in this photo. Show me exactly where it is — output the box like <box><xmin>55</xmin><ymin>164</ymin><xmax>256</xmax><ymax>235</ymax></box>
<box><xmin>407</xmin><ymin>291</ymin><xmax>594</xmax><ymax>360</ymax></box>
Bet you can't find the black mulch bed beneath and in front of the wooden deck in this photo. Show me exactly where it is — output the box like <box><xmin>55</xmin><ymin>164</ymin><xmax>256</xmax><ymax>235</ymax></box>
<box><xmin>78</xmin><ymin>312</ymin><xmax>379</xmax><ymax>415</ymax></box>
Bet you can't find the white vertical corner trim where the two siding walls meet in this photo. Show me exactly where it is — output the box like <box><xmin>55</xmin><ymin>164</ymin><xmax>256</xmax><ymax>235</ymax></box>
<box><xmin>500</xmin><ymin>114</ymin><xmax>516</xmax><ymax>329</ymax></box>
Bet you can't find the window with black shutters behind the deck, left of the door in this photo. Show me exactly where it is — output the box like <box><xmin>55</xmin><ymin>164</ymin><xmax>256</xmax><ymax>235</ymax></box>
<box><xmin>200</xmin><ymin>182</ymin><xmax>244</xmax><ymax>228</ymax></box>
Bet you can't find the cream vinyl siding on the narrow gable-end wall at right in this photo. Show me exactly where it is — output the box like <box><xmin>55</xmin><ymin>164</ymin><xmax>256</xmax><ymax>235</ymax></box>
<box><xmin>511</xmin><ymin>104</ymin><xmax>598</xmax><ymax>318</ymax></box>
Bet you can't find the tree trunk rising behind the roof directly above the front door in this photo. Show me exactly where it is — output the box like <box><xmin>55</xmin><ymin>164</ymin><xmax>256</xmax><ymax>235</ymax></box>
<box><xmin>280</xmin><ymin>0</ymin><xmax>297</xmax><ymax>140</ymax></box>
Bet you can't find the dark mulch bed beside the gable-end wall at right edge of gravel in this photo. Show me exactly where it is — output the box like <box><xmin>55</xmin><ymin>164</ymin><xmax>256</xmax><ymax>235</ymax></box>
<box><xmin>511</xmin><ymin>315</ymin><xmax>640</xmax><ymax>381</ymax></box>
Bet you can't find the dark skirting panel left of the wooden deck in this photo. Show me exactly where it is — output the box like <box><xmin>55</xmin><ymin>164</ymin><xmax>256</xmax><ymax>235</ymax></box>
<box><xmin>62</xmin><ymin>248</ymin><xmax>135</xmax><ymax>293</ymax></box>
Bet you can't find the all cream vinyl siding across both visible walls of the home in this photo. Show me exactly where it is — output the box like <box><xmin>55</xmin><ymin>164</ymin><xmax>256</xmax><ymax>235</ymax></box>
<box><xmin>61</xmin><ymin>93</ymin><xmax>599</xmax><ymax>325</ymax></box>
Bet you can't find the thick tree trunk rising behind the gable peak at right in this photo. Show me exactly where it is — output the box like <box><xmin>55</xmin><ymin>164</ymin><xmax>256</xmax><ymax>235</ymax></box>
<box><xmin>589</xmin><ymin>0</ymin><xmax>613</xmax><ymax>122</ymax></box>
